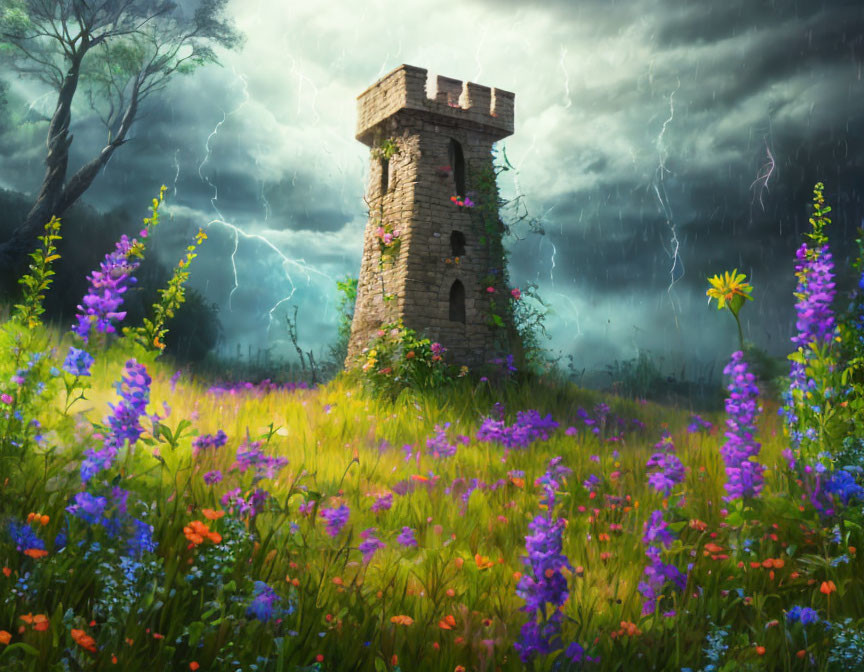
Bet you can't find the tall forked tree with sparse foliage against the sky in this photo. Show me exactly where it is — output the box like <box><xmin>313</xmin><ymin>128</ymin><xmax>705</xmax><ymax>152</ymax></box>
<box><xmin>0</xmin><ymin>0</ymin><xmax>242</xmax><ymax>286</ymax></box>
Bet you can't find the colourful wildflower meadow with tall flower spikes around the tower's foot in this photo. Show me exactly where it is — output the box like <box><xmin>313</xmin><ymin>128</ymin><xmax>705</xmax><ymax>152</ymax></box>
<box><xmin>0</xmin><ymin>184</ymin><xmax>864</xmax><ymax>672</ymax></box>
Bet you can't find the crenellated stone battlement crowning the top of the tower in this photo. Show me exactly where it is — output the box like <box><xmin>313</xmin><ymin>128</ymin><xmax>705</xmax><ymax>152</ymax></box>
<box><xmin>355</xmin><ymin>64</ymin><xmax>515</xmax><ymax>146</ymax></box>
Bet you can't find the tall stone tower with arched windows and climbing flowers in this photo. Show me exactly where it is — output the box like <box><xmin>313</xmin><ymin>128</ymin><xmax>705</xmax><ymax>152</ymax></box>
<box><xmin>346</xmin><ymin>65</ymin><xmax>514</xmax><ymax>367</ymax></box>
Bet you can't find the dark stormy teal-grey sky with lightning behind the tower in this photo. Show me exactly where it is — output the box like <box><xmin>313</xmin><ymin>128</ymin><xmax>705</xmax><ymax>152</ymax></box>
<box><xmin>0</xmin><ymin>0</ymin><xmax>864</xmax><ymax>375</ymax></box>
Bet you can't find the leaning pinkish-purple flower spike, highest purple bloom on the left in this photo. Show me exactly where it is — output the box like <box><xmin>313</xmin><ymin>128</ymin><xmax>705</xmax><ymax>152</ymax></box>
<box><xmin>72</xmin><ymin>235</ymin><xmax>140</xmax><ymax>343</ymax></box>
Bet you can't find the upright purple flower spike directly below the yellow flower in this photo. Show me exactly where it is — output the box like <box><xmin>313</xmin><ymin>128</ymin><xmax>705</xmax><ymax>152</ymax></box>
<box><xmin>720</xmin><ymin>350</ymin><xmax>765</xmax><ymax>501</ymax></box>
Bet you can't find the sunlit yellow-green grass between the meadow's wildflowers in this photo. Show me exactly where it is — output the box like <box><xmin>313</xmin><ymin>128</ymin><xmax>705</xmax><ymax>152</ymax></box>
<box><xmin>0</xmin><ymin>328</ymin><xmax>864</xmax><ymax>672</ymax></box>
